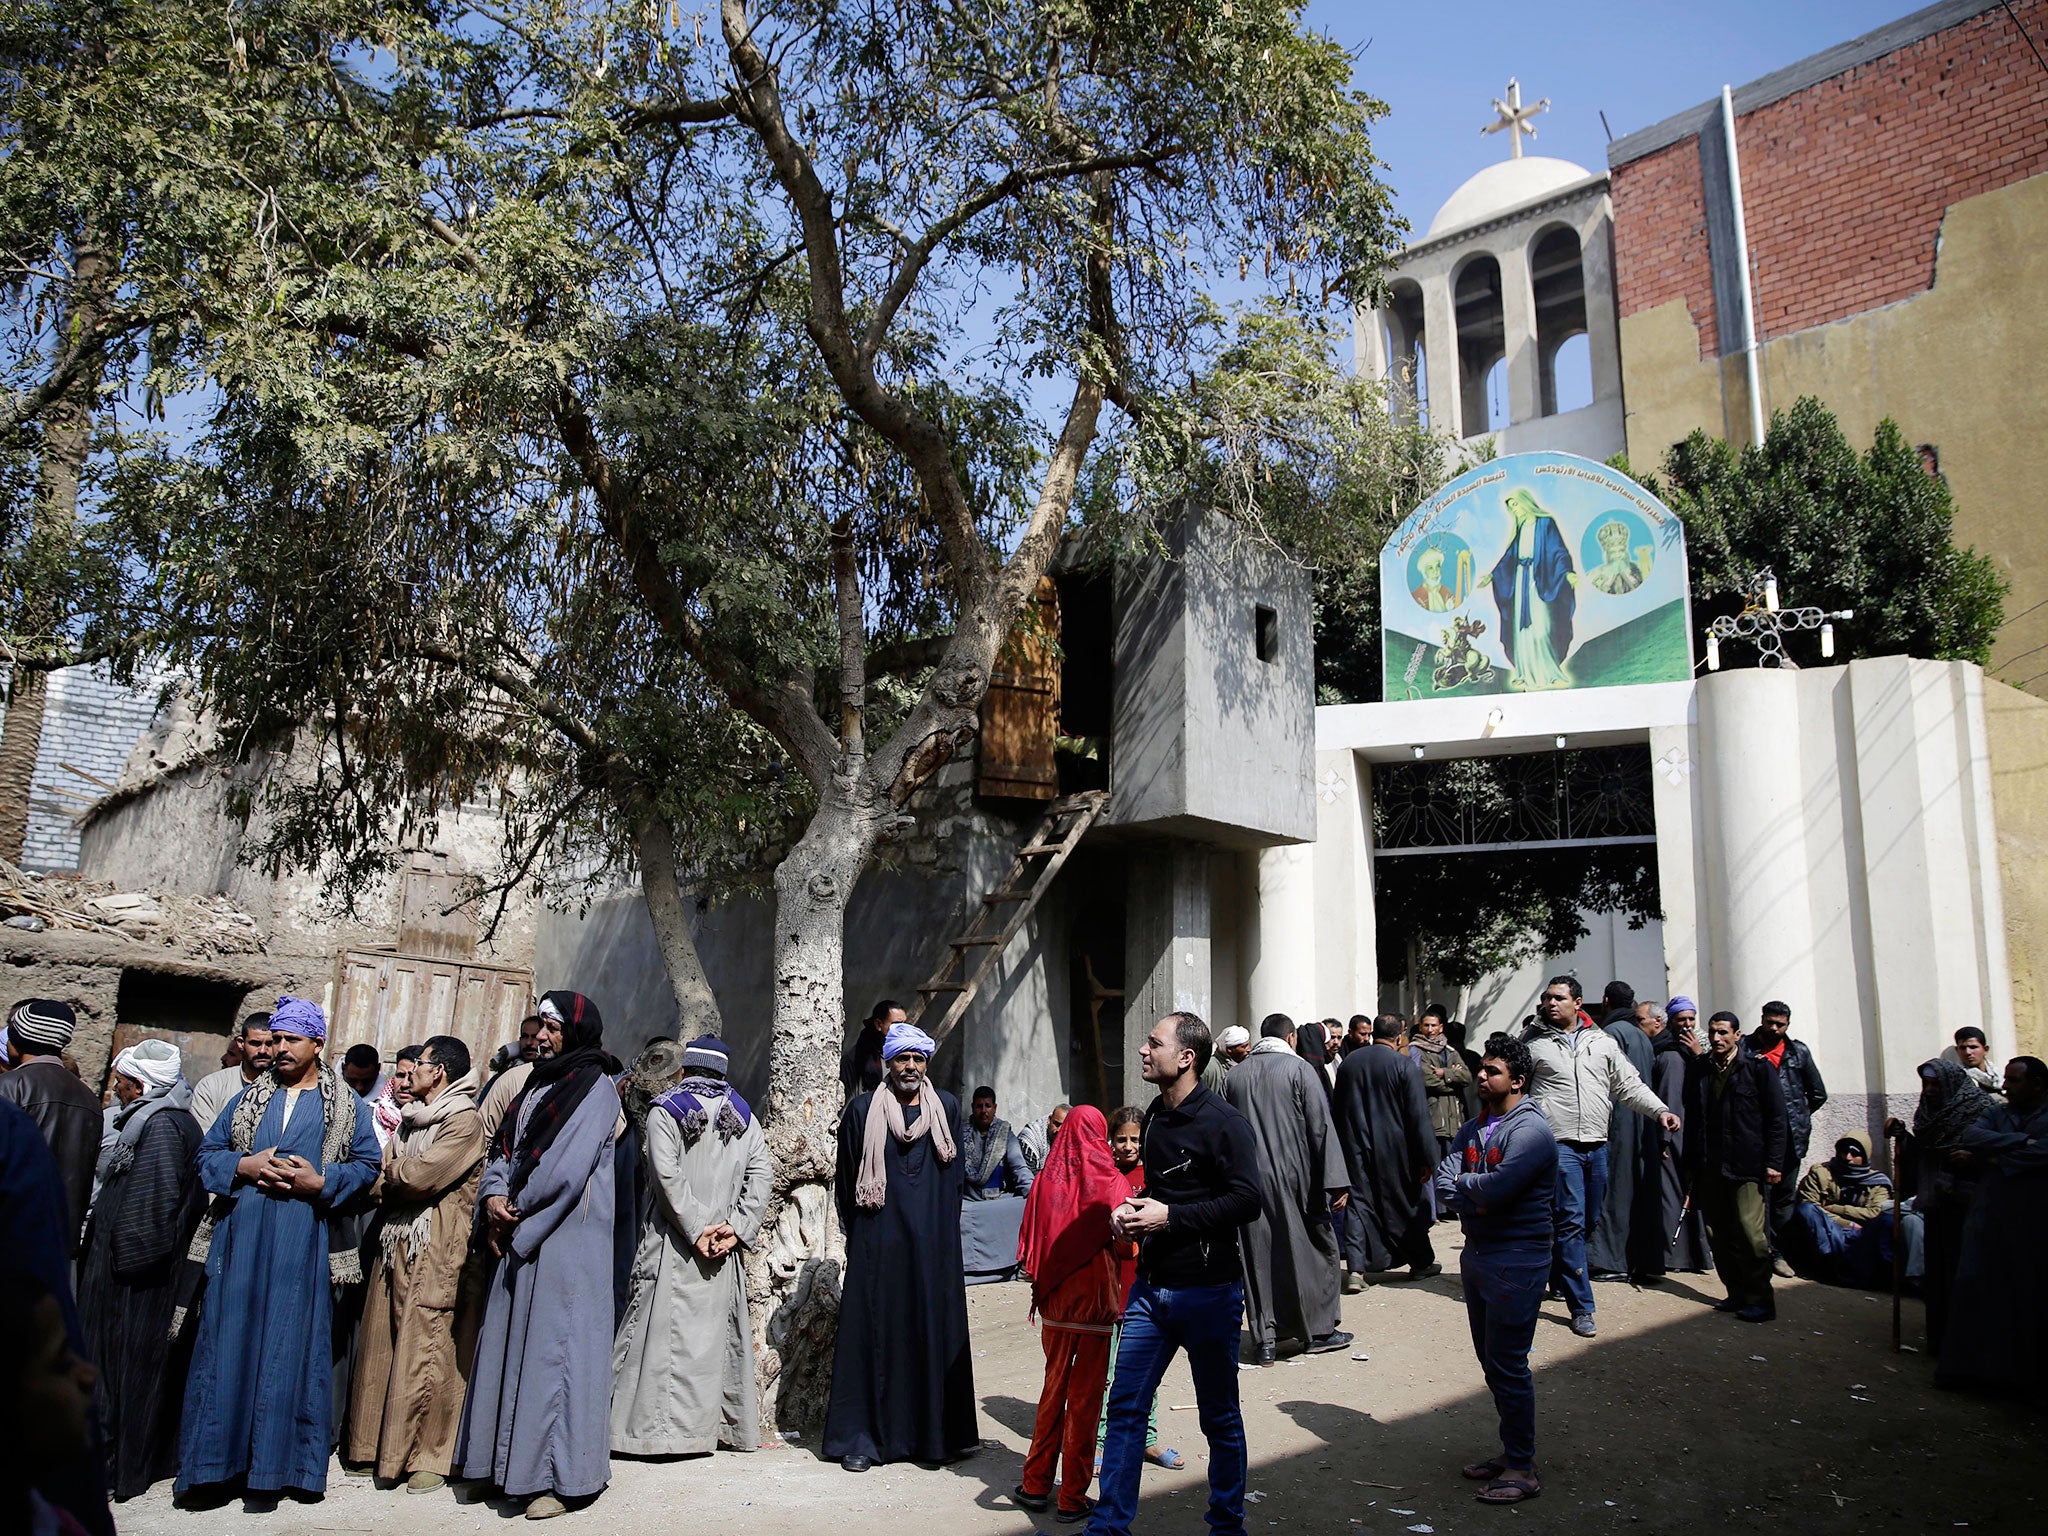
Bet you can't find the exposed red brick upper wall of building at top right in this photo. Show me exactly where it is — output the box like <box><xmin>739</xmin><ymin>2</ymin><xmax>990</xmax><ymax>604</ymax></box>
<box><xmin>1612</xmin><ymin>0</ymin><xmax>2048</xmax><ymax>356</ymax></box>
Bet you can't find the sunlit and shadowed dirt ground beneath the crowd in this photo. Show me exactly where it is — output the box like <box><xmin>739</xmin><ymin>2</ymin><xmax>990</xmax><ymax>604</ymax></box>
<box><xmin>117</xmin><ymin>1229</ymin><xmax>2048</xmax><ymax>1536</ymax></box>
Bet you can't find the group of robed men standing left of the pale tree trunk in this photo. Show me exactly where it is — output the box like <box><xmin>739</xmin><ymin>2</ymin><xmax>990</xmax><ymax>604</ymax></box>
<box><xmin>0</xmin><ymin>991</ymin><xmax>770</xmax><ymax>1532</ymax></box>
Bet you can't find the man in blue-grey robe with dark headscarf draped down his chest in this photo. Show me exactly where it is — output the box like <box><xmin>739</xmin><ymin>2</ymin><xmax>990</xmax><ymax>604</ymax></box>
<box><xmin>455</xmin><ymin>991</ymin><xmax>623</xmax><ymax>1520</ymax></box>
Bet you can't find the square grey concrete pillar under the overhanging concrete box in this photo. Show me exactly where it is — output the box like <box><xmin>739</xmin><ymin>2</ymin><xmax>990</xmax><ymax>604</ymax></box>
<box><xmin>1124</xmin><ymin>842</ymin><xmax>1214</xmax><ymax>1104</ymax></box>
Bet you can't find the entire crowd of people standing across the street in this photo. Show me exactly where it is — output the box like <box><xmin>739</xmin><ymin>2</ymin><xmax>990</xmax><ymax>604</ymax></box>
<box><xmin>0</xmin><ymin>977</ymin><xmax>2048</xmax><ymax>1536</ymax></box>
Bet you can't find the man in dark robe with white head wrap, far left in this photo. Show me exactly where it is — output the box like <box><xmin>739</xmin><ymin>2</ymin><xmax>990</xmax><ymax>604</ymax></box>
<box><xmin>78</xmin><ymin>1040</ymin><xmax>205</xmax><ymax>1499</ymax></box>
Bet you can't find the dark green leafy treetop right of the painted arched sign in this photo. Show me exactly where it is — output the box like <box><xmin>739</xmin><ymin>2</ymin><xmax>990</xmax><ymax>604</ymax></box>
<box><xmin>1622</xmin><ymin>397</ymin><xmax>2007</xmax><ymax>666</ymax></box>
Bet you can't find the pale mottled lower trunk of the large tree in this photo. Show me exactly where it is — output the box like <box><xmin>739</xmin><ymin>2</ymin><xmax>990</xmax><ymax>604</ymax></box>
<box><xmin>748</xmin><ymin>778</ymin><xmax>889</xmax><ymax>1440</ymax></box>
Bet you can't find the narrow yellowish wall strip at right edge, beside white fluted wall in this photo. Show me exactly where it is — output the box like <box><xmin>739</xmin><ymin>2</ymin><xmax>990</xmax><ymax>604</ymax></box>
<box><xmin>1985</xmin><ymin>678</ymin><xmax>2048</xmax><ymax>1057</ymax></box>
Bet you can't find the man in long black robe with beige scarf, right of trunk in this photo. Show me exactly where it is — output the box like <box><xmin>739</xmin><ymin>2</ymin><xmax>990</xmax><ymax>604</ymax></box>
<box><xmin>825</xmin><ymin>1024</ymin><xmax>981</xmax><ymax>1473</ymax></box>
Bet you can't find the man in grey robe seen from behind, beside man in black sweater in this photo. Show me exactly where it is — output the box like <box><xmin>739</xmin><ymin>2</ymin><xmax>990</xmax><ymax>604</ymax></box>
<box><xmin>1223</xmin><ymin>1014</ymin><xmax>1352</xmax><ymax>1366</ymax></box>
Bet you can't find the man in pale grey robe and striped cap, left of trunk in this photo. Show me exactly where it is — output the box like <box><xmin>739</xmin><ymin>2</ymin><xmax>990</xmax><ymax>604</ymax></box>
<box><xmin>612</xmin><ymin>1034</ymin><xmax>772</xmax><ymax>1456</ymax></box>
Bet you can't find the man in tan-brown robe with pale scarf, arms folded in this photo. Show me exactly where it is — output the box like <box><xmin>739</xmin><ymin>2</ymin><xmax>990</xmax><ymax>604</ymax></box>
<box><xmin>348</xmin><ymin>1034</ymin><xmax>483</xmax><ymax>1493</ymax></box>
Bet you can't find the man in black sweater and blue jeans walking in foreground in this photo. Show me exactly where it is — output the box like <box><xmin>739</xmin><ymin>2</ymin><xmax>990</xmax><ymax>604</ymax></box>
<box><xmin>1087</xmin><ymin>1014</ymin><xmax>1260</xmax><ymax>1536</ymax></box>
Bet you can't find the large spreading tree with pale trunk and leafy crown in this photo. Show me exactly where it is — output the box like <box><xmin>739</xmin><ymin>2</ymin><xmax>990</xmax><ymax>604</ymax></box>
<box><xmin>24</xmin><ymin>0</ymin><xmax>1391</xmax><ymax>1419</ymax></box>
